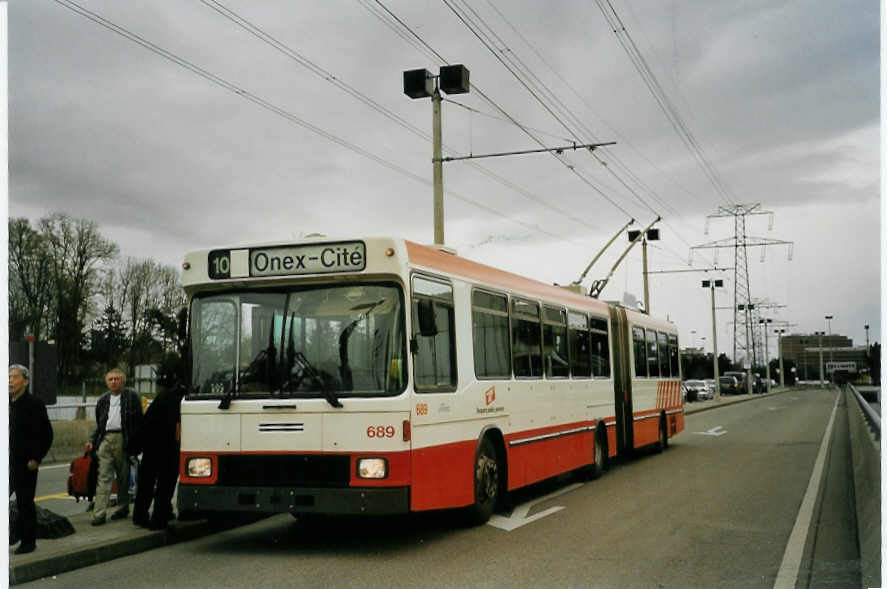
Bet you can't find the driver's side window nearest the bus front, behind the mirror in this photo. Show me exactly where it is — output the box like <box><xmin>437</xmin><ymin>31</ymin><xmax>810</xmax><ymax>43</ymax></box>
<box><xmin>411</xmin><ymin>276</ymin><xmax>457</xmax><ymax>392</ymax></box>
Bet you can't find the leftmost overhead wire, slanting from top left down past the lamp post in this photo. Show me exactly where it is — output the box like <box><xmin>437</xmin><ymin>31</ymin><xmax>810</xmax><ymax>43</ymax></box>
<box><xmin>55</xmin><ymin>0</ymin><xmax>586</xmax><ymax>250</ymax></box>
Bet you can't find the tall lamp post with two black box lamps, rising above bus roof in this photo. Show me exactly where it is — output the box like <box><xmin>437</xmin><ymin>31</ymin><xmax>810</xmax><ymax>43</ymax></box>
<box><xmin>403</xmin><ymin>64</ymin><xmax>469</xmax><ymax>245</ymax></box>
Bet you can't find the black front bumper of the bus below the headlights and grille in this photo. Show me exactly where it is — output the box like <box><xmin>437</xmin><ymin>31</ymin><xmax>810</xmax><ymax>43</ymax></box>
<box><xmin>178</xmin><ymin>484</ymin><xmax>410</xmax><ymax>515</ymax></box>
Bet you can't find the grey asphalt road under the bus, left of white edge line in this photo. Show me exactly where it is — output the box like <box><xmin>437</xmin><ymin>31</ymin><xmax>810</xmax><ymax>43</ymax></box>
<box><xmin>22</xmin><ymin>390</ymin><xmax>854</xmax><ymax>589</ymax></box>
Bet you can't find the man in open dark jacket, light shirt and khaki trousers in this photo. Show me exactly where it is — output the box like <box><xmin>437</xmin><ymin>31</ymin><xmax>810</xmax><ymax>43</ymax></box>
<box><xmin>86</xmin><ymin>368</ymin><xmax>142</xmax><ymax>526</ymax></box>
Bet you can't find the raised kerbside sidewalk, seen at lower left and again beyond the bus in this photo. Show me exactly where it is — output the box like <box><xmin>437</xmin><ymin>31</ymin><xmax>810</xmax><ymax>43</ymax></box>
<box><xmin>9</xmin><ymin>389</ymin><xmax>790</xmax><ymax>585</ymax></box>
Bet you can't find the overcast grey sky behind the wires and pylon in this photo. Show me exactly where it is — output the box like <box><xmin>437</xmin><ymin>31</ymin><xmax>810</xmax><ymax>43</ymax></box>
<box><xmin>8</xmin><ymin>0</ymin><xmax>883</xmax><ymax>356</ymax></box>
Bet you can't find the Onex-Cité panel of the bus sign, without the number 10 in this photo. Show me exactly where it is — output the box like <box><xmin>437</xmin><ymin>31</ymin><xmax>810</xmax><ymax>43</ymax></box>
<box><xmin>249</xmin><ymin>241</ymin><xmax>366</xmax><ymax>276</ymax></box>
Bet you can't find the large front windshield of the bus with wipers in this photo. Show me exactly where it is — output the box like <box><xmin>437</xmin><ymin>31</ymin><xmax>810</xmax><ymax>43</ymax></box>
<box><xmin>190</xmin><ymin>284</ymin><xmax>406</xmax><ymax>402</ymax></box>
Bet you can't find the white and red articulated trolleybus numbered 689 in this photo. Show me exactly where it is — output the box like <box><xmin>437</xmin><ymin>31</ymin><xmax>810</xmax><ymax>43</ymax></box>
<box><xmin>178</xmin><ymin>238</ymin><xmax>684</xmax><ymax>522</ymax></box>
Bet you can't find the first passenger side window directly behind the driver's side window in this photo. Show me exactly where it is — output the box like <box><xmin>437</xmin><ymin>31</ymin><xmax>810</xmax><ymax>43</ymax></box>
<box><xmin>471</xmin><ymin>290</ymin><xmax>511</xmax><ymax>378</ymax></box>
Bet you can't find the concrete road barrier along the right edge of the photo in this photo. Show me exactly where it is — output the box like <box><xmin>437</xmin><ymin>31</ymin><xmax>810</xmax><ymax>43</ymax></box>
<box><xmin>845</xmin><ymin>385</ymin><xmax>881</xmax><ymax>587</ymax></box>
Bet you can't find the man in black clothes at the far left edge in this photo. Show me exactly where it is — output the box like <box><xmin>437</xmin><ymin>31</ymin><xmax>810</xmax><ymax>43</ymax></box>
<box><xmin>9</xmin><ymin>364</ymin><xmax>52</xmax><ymax>554</ymax></box>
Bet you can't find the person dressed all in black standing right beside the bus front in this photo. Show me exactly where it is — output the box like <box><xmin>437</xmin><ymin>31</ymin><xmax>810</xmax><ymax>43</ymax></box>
<box><xmin>132</xmin><ymin>389</ymin><xmax>182</xmax><ymax>530</ymax></box>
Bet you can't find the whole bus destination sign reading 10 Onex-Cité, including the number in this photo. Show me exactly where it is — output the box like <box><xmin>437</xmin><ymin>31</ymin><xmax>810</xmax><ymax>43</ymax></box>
<box><xmin>207</xmin><ymin>241</ymin><xmax>366</xmax><ymax>280</ymax></box>
